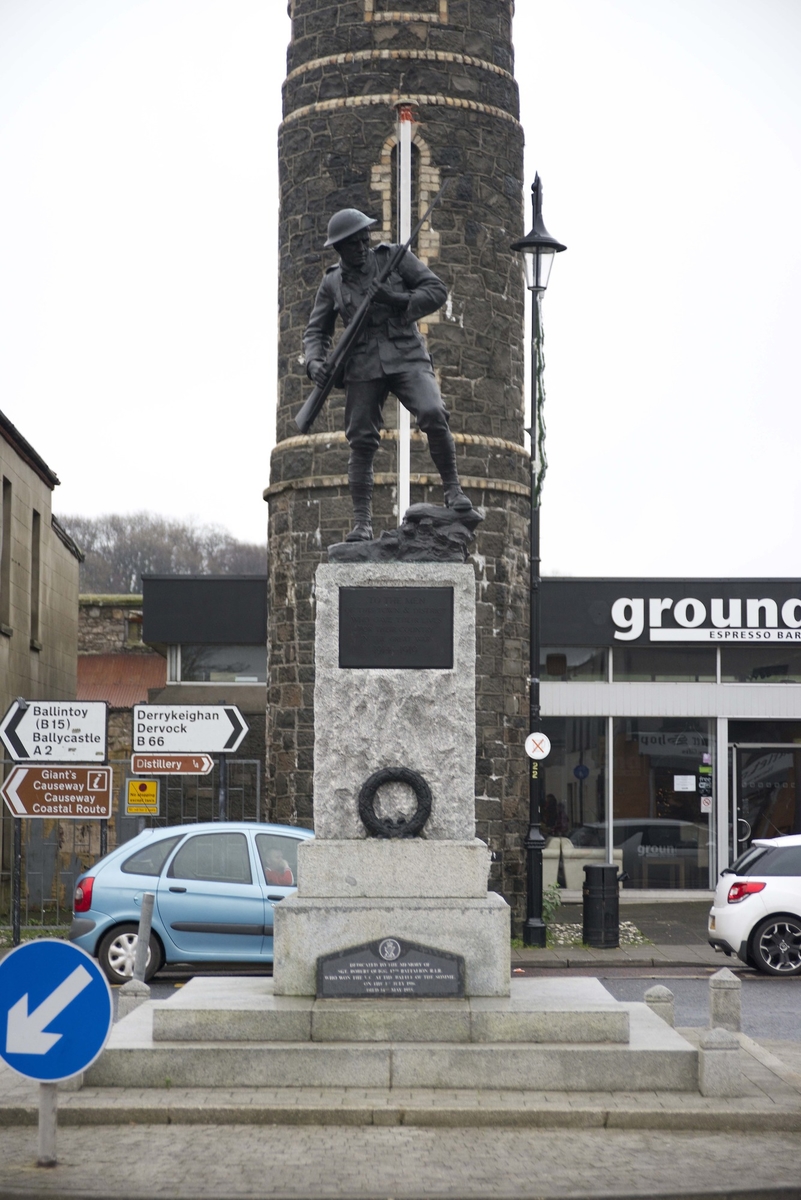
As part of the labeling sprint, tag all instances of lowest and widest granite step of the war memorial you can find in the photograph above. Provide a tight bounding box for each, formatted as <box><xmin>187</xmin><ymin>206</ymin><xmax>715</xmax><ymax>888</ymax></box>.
<box><xmin>85</xmin><ymin>1004</ymin><xmax>698</xmax><ymax>1092</ymax></box>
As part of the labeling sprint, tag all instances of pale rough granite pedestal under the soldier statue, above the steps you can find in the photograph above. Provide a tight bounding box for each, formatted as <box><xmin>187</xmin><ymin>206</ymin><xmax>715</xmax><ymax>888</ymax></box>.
<box><xmin>273</xmin><ymin>562</ymin><xmax>511</xmax><ymax>1002</ymax></box>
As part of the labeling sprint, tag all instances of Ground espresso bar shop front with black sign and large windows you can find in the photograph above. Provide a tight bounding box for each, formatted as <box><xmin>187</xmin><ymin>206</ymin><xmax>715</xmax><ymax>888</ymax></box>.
<box><xmin>540</xmin><ymin>578</ymin><xmax>801</xmax><ymax>893</ymax></box>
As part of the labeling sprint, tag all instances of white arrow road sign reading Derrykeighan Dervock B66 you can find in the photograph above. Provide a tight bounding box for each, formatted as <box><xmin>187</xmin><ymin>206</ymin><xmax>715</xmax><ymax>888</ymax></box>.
<box><xmin>133</xmin><ymin>704</ymin><xmax>248</xmax><ymax>754</ymax></box>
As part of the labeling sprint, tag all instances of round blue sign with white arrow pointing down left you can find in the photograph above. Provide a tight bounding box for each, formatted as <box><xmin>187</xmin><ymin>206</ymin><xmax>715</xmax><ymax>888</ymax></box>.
<box><xmin>0</xmin><ymin>938</ymin><xmax>114</xmax><ymax>1084</ymax></box>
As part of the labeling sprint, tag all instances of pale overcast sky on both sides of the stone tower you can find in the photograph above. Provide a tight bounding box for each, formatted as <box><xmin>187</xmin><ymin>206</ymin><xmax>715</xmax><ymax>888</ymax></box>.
<box><xmin>0</xmin><ymin>0</ymin><xmax>801</xmax><ymax>576</ymax></box>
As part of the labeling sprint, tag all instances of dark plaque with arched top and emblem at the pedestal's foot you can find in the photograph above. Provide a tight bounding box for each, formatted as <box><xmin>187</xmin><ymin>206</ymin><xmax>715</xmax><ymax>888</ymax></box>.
<box><xmin>317</xmin><ymin>937</ymin><xmax>464</xmax><ymax>1000</ymax></box>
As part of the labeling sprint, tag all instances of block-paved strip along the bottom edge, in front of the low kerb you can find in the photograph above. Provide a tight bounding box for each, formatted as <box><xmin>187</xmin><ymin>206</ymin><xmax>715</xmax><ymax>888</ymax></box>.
<box><xmin>0</xmin><ymin>1126</ymin><xmax>801</xmax><ymax>1200</ymax></box>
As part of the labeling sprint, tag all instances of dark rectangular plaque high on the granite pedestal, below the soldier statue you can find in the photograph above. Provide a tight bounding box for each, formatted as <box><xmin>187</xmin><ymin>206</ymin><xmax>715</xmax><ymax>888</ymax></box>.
<box><xmin>339</xmin><ymin>588</ymin><xmax>453</xmax><ymax>671</ymax></box>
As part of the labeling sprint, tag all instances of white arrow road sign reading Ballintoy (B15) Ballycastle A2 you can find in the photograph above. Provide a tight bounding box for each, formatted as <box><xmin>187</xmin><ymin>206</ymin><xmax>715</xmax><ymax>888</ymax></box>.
<box><xmin>0</xmin><ymin>700</ymin><xmax>108</xmax><ymax>762</ymax></box>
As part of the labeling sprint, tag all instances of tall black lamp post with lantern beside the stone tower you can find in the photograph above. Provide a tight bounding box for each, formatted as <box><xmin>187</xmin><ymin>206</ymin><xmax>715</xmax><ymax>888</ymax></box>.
<box><xmin>511</xmin><ymin>175</ymin><xmax>567</xmax><ymax>946</ymax></box>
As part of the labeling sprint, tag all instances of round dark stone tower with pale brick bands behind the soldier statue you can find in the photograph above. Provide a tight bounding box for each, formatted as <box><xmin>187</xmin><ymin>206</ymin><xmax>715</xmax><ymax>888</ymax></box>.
<box><xmin>264</xmin><ymin>0</ymin><xmax>529</xmax><ymax>920</ymax></box>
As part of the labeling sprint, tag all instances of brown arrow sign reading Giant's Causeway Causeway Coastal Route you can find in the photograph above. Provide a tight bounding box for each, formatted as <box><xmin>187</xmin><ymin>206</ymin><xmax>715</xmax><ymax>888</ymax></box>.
<box><xmin>0</xmin><ymin>763</ymin><xmax>112</xmax><ymax>821</ymax></box>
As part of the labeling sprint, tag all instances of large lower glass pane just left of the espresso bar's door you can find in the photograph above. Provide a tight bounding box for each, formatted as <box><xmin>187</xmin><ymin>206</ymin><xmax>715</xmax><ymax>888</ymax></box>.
<box><xmin>613</xmin><ymin>718</ymin><xmax>713</xmax><ymax>889</ymax></box>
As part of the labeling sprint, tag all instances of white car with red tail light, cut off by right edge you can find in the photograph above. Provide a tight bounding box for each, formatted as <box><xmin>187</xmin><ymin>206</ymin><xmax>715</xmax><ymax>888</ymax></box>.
<box><xmin>707</xmin><ymin>834</ymin><xmax>801</xmax><ymax>976</ymax></box>
